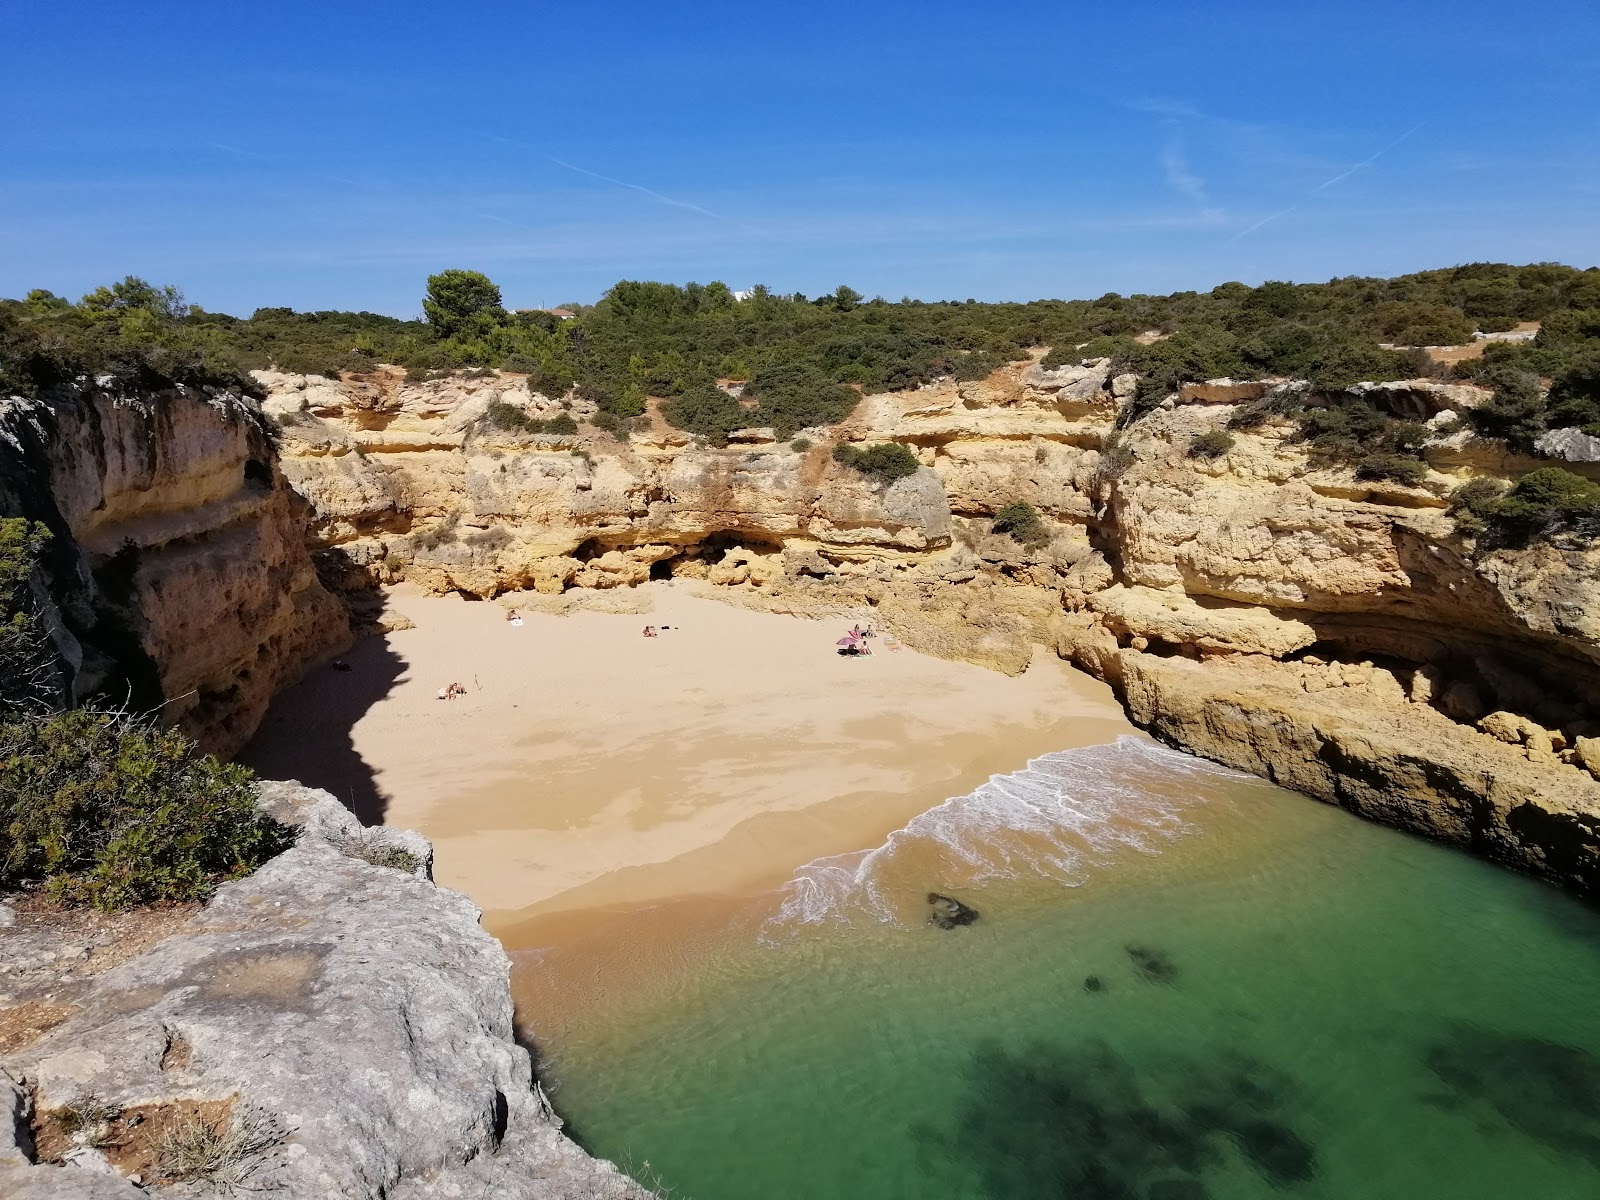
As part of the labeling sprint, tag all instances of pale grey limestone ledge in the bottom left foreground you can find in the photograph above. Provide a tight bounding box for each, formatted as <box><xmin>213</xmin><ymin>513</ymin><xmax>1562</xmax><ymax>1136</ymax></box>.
<box><xmin>0</xmin><ymin>784</ymin><xmax>648</xmax><ymax>1200</ymax></box>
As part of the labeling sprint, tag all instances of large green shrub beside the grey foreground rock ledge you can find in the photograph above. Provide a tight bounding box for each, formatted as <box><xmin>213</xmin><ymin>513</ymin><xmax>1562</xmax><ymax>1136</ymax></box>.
<box><xmin>0</xmin><ymin>709</ymin><xmax>291</xmax><ymax>909</ymax></box>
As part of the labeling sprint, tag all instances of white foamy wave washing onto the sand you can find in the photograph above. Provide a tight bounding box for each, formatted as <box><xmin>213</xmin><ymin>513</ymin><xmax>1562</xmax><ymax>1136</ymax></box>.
<box><xmin>768</xmin><ymin>736</ymin><xmax>1248</xmax><ymax>934</ymax></box>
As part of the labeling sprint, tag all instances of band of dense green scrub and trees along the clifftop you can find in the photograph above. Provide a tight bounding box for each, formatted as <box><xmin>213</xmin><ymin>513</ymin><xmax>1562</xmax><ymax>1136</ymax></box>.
<box><xmin>0</xmin><ymin>262</ymin><xmax>1600</xmax><ymax>458</ymax></box>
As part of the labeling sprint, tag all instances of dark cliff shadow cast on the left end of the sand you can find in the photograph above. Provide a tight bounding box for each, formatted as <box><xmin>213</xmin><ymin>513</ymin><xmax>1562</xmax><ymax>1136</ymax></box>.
<box><xmin>238</xmin><ymin>637</ymin><xmax>408</xmax><ymax>826</ymax></box>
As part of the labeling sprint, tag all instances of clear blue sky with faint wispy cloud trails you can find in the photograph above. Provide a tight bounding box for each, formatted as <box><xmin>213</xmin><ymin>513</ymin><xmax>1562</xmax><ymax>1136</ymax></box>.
<box><xmin>0</xmin><ymin>0</ymin><xmax>1600</xmax><ymax>315</ymax></box>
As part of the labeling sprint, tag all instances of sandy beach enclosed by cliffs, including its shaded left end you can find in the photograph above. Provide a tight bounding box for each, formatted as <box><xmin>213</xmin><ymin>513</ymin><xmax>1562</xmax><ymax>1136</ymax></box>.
<box><xmin>243</xmin><ymin>582</ymin><xmax>1131</xmax><ymax>944</ymax></box>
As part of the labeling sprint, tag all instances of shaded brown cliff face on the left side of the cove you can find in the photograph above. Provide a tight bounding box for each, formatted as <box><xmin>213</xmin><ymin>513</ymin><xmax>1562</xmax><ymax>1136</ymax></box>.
<box><xmin>0</xmin><ymin>384</ymin><xmax>349</xmax><ymax>754</ymax></box>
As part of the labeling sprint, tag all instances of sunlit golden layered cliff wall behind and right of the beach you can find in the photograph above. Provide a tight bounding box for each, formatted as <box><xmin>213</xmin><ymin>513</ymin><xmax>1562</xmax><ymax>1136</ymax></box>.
<box><xmin>261</xmin><ymin>362</ymin><xmax>1600</xmax><ymax>890</ymax></box>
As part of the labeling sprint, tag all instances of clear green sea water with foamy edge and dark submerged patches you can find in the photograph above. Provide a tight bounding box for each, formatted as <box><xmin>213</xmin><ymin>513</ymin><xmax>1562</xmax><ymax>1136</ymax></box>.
<box><xmin>531</xmin><ymin>738</ymin><xmax>1600</xmax><ymax>1200</ymax></box>
